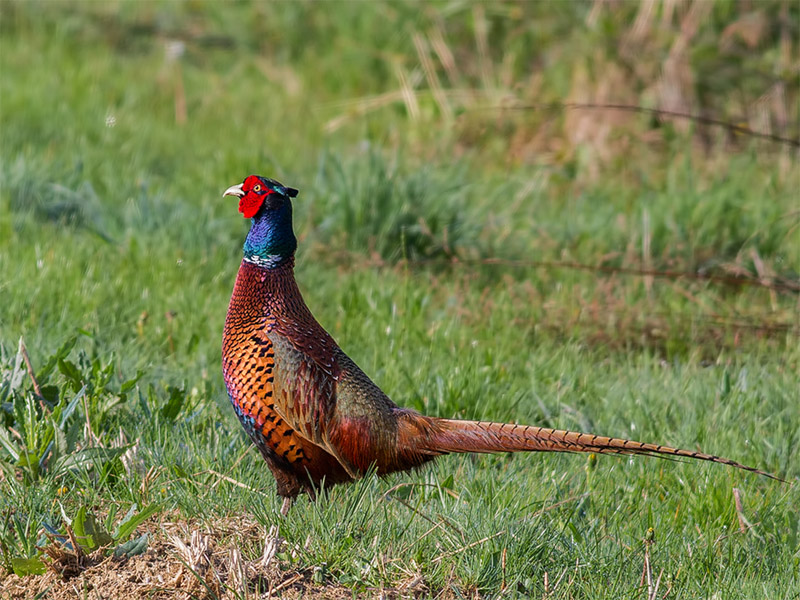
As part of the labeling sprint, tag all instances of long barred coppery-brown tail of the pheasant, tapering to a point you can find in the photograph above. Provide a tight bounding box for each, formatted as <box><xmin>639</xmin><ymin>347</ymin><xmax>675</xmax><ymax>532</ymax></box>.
<box><xmin>420</xmin><ymin>419</ymin><xmax>783</xmax><ymax>481</ymax></box>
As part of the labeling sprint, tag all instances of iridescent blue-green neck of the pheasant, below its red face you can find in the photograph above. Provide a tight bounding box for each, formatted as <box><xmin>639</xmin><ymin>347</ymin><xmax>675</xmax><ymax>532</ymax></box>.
<box><xmin>244</xmin><ymin>201</ymin><xmax>297</xmax><ymax>269</ymax></box>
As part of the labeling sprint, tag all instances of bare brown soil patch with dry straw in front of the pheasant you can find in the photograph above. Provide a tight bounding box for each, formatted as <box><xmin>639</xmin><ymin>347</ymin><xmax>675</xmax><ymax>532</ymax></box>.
<box><xmin>0</xmin><ymin>522</ymin><xmax>425</xmax><ymax>600</ymax></box>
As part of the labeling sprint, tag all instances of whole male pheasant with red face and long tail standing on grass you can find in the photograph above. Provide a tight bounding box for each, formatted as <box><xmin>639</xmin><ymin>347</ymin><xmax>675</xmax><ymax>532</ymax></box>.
<box><xmin>222</xmin><ymin>175</ymin><xmax>775</xmax><ymax>514</ymax></box>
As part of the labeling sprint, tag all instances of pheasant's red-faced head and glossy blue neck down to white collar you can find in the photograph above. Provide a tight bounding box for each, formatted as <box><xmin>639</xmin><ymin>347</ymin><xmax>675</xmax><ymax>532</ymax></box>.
<box><xmin>223</xmin><ymin>175</ymin><xmax>297</xmax><ymax>269</ymax></box>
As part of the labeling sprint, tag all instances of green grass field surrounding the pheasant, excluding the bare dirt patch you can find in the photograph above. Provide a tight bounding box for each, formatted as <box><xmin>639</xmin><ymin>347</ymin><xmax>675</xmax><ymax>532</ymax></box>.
<box><xmin>0</xmin><ymin>2</ymin><xmax>800</xmax><ymax>599</ymax></box>
